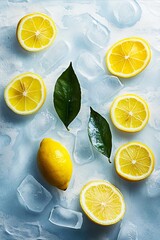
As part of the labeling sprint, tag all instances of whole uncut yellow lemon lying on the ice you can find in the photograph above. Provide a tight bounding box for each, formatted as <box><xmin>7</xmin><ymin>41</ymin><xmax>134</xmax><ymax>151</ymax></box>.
<box><xmin>37</xmin><ymin>138</ymin><xmax>73</xmax><ymax>190</ymax></box>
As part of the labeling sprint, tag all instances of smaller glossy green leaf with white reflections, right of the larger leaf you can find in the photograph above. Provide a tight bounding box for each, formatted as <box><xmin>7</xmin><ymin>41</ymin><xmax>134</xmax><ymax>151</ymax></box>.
<box><xmin>88</xmin><ymin>108</ymin><xmax>112</xmax><ymax>162</ymax></box>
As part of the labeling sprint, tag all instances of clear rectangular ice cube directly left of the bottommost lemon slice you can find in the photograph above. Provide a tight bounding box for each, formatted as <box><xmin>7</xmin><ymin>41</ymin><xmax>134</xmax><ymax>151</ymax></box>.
<box><xmin>49</xmin><ymin>206</ymin><xmax>83</xmax><ymax>229</ymax></box>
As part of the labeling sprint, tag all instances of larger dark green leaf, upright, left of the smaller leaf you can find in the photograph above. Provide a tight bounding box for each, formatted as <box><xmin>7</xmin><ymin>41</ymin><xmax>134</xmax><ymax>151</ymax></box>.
<box><xmin>54</xmin><ymin>63</ymin><xmax>81</xmax><ymax>129</ymax></box>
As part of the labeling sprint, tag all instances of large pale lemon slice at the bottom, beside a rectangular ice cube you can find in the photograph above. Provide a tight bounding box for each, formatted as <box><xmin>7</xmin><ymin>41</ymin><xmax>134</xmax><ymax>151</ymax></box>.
<box><xmin>80</xmin><ymin>180</ymin><xmax>125</xmax><ymax>225</ymax></box>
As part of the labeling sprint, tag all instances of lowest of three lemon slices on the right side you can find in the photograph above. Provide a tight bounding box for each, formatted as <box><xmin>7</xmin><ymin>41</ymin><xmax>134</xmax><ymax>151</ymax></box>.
<box><xmin>115</xmin><ymin>142</ymin><xmax>155</xmax><ymax>181</ymax></box>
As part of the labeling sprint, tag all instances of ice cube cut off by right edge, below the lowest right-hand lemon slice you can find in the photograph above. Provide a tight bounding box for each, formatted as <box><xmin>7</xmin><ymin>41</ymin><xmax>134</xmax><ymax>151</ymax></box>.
<box><xmin>146</xmin><ymin>169</ymin><xmax>160</xmax><ymax>198</ymax></box>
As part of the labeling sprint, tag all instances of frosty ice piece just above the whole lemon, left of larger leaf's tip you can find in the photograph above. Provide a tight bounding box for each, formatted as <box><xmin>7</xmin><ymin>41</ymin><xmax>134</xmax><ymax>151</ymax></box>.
<box><xmin>27</xmin><ymin>110</ymin><xmax>57</xmax><ymax>139</ymax></box>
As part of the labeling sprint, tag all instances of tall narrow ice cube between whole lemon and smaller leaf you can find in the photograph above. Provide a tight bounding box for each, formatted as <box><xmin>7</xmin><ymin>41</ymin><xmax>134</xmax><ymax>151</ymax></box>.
<box><xmin>74</xmin><ymin>129</ymin><xmax>94</xmax><ymax>164</ymax></box>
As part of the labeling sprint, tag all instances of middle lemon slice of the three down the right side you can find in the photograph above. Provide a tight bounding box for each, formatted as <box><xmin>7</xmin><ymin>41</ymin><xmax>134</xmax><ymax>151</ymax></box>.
<box><xmin>110</xmin><ymin>94</ymin><xmax>150</xmax><ymax>132</ymax></box>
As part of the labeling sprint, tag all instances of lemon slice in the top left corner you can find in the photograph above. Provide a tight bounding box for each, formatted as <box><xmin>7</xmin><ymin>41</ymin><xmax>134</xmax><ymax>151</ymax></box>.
<box><xmin>17</xmin><ymin>13</ymin><xmax>57</xmax><ymax>52</ymax></box>
